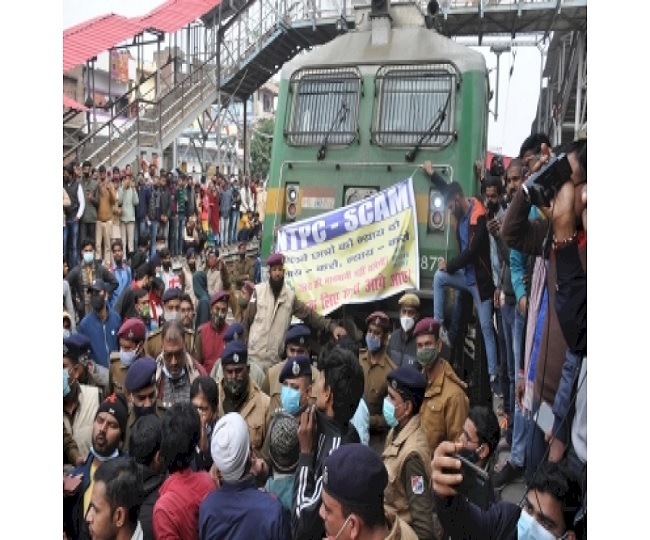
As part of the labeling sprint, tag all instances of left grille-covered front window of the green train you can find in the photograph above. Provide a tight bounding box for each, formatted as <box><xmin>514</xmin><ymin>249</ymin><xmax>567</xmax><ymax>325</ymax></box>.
<box><xmin>285</xmin><ymin>68</ymin><xmax>361</xmax><ymax>146</ymax></box>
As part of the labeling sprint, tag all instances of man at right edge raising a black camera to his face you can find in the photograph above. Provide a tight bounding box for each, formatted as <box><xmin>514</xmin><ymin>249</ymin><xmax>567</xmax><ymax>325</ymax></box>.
<box><xmin>501</xmin><ymin>140</ymin><xmax>587</xmax><ymax>486</ymax></box>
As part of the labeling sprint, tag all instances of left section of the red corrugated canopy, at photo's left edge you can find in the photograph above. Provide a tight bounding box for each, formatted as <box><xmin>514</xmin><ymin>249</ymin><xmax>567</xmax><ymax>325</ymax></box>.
<box><xmin>63</xmin><ymin>13</ymin><xmax>145</xmax><ymax>73</ymax></box>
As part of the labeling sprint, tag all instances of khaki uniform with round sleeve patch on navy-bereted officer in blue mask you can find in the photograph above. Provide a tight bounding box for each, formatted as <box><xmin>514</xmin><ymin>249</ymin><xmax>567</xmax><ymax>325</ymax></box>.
<box><xmin>381</xmin><ymin>414</ymin><xmax>434</xmax><ymax>540</ymax></box>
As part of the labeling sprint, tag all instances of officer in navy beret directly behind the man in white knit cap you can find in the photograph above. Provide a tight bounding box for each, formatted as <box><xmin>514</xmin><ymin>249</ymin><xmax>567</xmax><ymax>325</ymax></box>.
<box><xmin>219</xmin><ymin>341</ymin><xmax>270</xmax><ymax>452</ymax></box>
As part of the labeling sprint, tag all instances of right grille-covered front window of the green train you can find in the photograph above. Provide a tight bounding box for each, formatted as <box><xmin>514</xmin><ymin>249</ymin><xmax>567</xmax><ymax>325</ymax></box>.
<box><xmin>371</xmin><ymin>64</ymin><xmax>456</xmax><ymax>148</ymax></box>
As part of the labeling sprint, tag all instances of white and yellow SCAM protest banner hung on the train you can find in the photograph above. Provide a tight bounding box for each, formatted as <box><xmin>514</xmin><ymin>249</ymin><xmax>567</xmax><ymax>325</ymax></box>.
<box><xmin>276</xmin><ymin>178</ymin><xmax>420</xmax><ymax>315</ymax></box>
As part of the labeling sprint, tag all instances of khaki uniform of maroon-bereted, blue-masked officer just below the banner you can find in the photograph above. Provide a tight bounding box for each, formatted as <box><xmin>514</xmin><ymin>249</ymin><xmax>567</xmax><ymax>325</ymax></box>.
<box><xmin>359</xmin><ymin>349</ymin><xmax>395</xmax><ymax>453</ymax></box>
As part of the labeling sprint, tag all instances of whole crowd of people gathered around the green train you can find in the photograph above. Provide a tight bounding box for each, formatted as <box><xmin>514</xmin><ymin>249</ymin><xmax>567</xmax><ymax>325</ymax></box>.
<box><xmin>63</xmin><ymin>134</ymin><xmax>586</xmax><ymax>540</ymax></box>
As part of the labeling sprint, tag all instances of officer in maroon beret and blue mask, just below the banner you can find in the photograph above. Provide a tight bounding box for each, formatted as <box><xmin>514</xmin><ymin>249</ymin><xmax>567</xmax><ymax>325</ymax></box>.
<box><xmin>359</xmin><ymin>311</ymin><xmax>395</xmax><ymax>454</ymax></box>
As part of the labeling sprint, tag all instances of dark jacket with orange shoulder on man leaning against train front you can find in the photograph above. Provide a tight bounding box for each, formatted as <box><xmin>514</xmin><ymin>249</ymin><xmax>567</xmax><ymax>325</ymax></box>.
<box><xmin>447</xmin><ymin>197</ymin><xmax>494</xmax><ymax>301</ymax></box>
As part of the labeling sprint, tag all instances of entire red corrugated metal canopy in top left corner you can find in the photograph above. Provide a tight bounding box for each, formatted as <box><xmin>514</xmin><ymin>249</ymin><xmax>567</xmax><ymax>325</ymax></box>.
<box><xmin>63</xmin><ymin>0</ymin><xmax>222</xmax><ymax>73</ymax></box>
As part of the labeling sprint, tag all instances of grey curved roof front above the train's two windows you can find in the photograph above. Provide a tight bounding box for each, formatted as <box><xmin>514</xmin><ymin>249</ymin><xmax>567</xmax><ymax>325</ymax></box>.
<box><xmin>281</xmin><ymin>27</ymin><xmax>486</xmax><ymax>79</ymax></box>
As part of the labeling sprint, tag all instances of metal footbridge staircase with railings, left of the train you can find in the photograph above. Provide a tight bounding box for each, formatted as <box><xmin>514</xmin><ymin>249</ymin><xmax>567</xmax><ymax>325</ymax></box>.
<box><xmin>64</xmin><ymin>0</ymin><xmax>354</xmax><ymax>168</ymax></box>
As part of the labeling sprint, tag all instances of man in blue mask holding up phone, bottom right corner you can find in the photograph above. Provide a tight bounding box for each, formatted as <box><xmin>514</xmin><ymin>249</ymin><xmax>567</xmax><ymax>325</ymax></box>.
<box><xmin>431</xmin><ymin>441</ymin><xmax>581</xmax><ymax>540</ymax></box>
